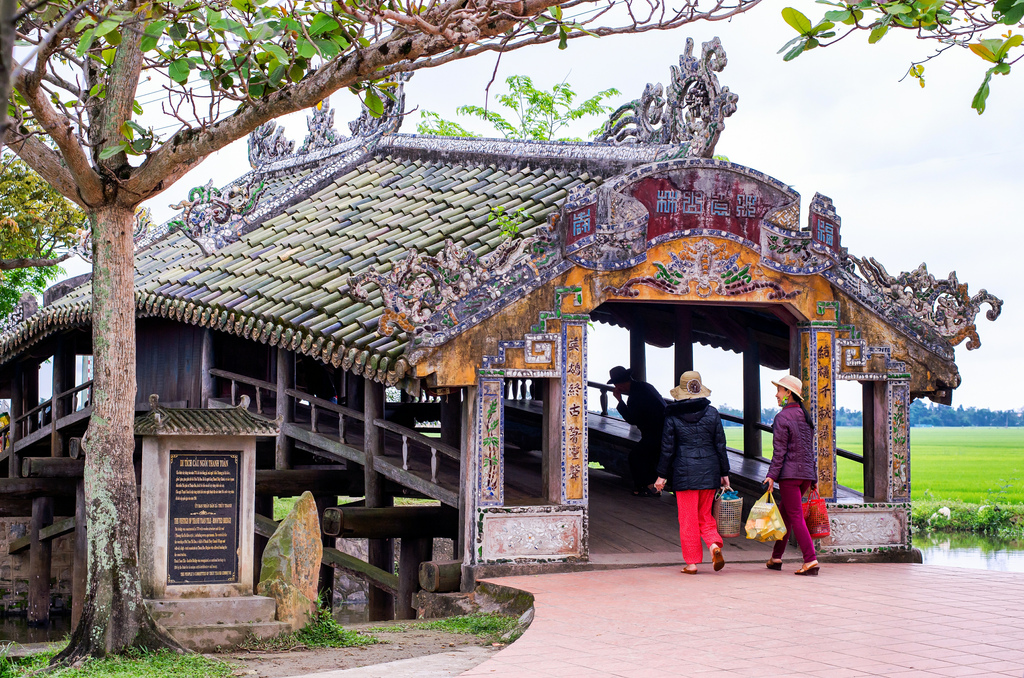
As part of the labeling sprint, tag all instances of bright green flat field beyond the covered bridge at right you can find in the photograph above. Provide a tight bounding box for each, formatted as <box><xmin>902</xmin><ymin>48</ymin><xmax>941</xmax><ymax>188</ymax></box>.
<box><xmin>725</xmin><ymin>426</ymin><xmax>1024</xmax><ymax>504</ymax></box>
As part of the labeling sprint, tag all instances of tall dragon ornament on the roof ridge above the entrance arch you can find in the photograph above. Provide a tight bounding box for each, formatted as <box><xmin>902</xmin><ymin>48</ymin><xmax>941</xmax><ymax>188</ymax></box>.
<box><xmin>596</xmin><ymin>38</ymin><xmax>739</xmax><ymax>158</ymax></box>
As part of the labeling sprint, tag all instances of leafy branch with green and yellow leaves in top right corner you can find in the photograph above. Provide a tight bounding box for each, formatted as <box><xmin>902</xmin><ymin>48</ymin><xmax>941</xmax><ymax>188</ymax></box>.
<box><xmin>779</xmin><ymin>0</ymin><xmax>1024</xmax><ymax>115</ymax></box>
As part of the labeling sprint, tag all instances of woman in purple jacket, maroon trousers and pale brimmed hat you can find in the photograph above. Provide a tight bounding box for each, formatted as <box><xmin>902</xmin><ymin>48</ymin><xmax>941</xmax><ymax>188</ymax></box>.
<box><xmin>765</xmin><ymin>375</ymin><xmax>818</xmax><ymax>577</ymax></box>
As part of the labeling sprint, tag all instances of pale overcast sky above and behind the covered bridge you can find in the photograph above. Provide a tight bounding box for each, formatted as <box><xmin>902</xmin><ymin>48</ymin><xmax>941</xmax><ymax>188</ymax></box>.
<box><xmin>58</xmin><ymin>2</ymin><xmax>1024</xmax><ymax>409</ymax></box>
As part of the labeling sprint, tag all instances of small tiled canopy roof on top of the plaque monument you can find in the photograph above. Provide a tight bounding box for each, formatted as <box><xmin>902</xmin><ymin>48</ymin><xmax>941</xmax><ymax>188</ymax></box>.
<box><xmin>135</xmin><ymin>393</ymin><xmax>280</xmax><ymax>435</ymax></box>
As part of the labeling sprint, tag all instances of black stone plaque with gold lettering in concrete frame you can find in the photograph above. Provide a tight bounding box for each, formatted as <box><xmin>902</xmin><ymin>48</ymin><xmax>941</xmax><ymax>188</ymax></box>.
<box><xmin>167</xmin><ymin>450</ymin><xmax>242</xmax><ymax>584</ymax></box>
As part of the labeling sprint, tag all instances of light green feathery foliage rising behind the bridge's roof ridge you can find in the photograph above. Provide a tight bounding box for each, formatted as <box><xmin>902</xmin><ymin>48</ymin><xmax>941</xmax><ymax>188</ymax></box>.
<box><xmin>417</xmin><ymin>75</ymin><xmax>620</xmax><ymax>141</ymax></box>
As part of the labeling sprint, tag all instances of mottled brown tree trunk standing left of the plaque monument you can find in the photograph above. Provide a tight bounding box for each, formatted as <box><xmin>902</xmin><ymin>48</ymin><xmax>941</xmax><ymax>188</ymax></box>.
<box><xmin>54</xmin><ymin>206</ymin><xmax>180</xmax><ymax>664</ymax></box>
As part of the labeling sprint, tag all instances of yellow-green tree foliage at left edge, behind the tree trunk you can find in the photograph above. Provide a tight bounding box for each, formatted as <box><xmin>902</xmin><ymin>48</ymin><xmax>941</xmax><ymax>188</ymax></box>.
<box><xmin>0</xmin><ymin>158</ymin><xmax>86</xmax><ymax>317</ymax></box>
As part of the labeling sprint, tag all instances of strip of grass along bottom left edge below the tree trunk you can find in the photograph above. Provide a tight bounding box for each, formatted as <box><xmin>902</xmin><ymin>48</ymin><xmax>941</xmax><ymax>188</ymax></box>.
<box><xmin>0</xmin><ymin>650</ymin><xmax>234</xmax><ymax>678</ymax></box>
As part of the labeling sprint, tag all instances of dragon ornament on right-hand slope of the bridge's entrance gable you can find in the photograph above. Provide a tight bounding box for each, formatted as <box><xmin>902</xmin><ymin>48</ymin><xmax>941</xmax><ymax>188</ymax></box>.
<box><xmin>850</xmin><ymin>256</ymin><xmax>1002</xmax><ymax>350</ymax></box>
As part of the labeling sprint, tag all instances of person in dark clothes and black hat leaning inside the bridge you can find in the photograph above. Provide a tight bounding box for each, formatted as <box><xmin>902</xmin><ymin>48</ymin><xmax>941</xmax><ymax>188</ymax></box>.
<box><xmin>608</xmin><ymin>367</ymin><xmax>665</xmax><ymax>497</ymax></box>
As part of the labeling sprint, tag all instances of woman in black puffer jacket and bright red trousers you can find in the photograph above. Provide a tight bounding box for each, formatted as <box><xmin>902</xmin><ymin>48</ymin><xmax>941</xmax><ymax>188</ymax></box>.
<box><xmin>654</xmin><ymin>372</ymin><xmax>729</xmax><ymax>575</ymax></box>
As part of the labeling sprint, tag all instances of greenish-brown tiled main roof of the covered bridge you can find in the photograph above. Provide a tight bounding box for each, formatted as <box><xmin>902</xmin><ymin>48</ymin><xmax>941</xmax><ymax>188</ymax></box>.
<box><xmin>0</xmin><ymin>135</ymin><xmax>665</xmax><ymax>386</ymax></box>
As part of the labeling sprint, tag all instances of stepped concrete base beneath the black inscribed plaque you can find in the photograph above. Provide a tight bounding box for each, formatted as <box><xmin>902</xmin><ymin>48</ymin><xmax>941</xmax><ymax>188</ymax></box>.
<box><xmin>145</xmin><ymin>596</ymin><xmax>292</xmax><ymax>652</ymax></box>
